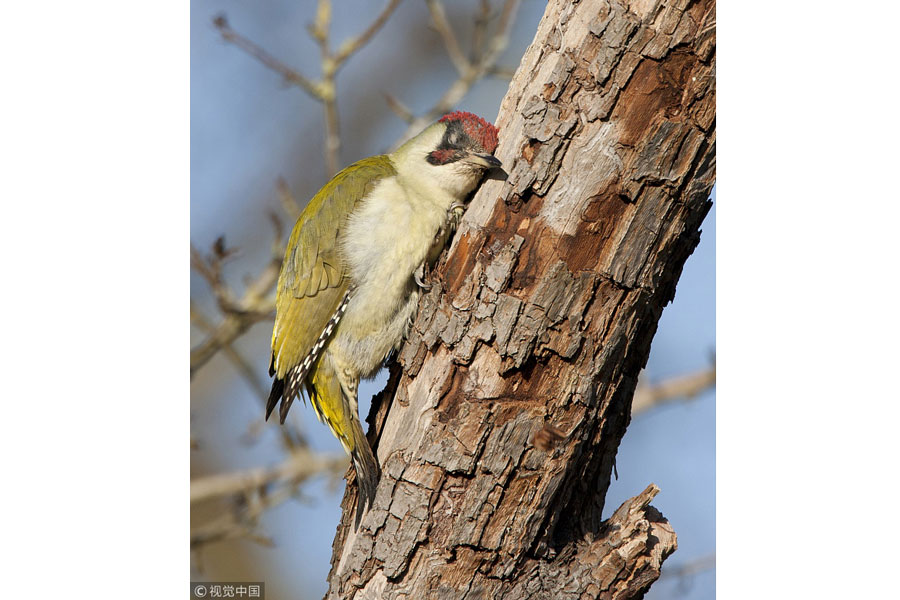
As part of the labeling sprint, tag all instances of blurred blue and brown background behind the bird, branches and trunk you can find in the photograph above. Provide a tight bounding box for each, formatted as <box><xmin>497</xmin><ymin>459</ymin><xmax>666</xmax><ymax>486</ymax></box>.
<box><xmin>190</xmin><ymin>0</ymin><xmax>716</xmax><ymax>600</ymax></box>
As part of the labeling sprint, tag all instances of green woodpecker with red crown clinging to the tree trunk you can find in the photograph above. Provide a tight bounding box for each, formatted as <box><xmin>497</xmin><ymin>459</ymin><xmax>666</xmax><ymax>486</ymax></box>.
<box><xmin>266</xmin><ymin>112</ymin><xmax>500</xmax><ymax>528</ymax></box>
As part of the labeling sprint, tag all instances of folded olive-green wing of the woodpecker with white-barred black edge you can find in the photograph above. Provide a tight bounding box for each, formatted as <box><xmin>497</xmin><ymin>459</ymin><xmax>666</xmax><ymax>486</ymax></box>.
<box><xmin>269</xmin><ymin>156</ymin><xmax>396</xmax><ymax>400</ymax></box>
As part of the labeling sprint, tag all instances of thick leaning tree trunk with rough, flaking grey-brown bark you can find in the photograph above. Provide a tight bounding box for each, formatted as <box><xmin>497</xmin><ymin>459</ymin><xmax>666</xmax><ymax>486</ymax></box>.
<box><xmin>326</xmin><ymin>0</ymin><xmax>716</xmax><ymax>600</ymax></box>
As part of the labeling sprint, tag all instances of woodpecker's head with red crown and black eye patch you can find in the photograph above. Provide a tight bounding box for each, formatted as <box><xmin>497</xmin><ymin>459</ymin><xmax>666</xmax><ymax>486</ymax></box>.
<box><xmin>397</xmin><ymin>111</ymin><xmax>502</xmax><ymax>199</ymax></box>
